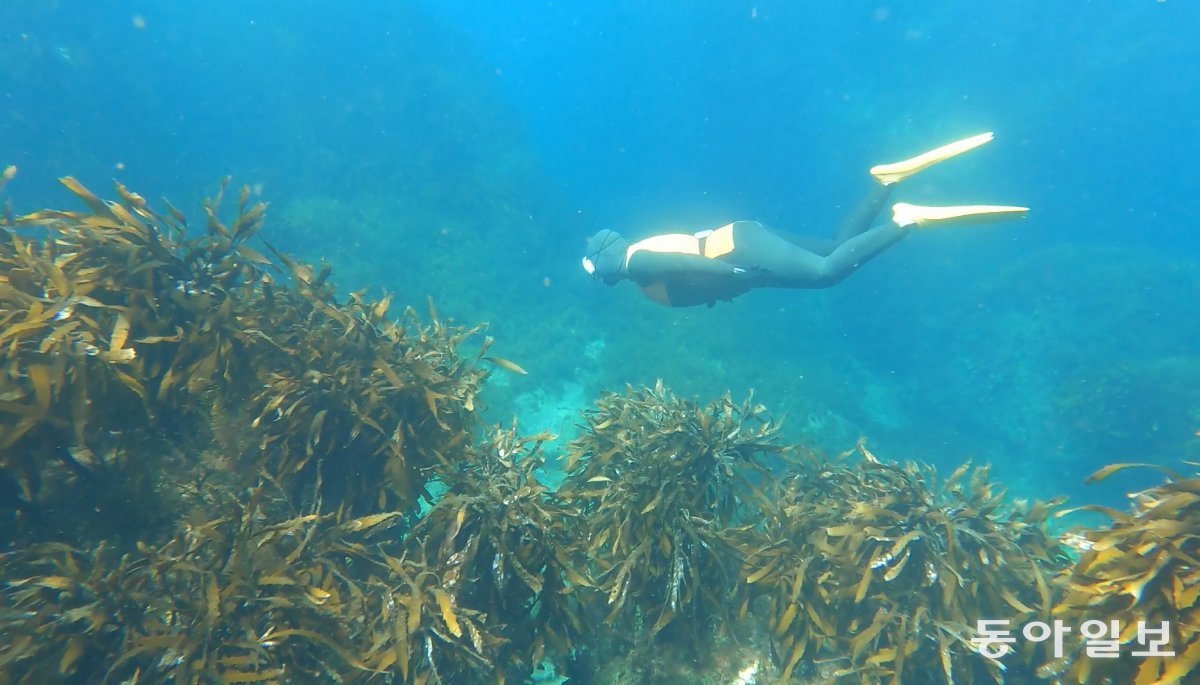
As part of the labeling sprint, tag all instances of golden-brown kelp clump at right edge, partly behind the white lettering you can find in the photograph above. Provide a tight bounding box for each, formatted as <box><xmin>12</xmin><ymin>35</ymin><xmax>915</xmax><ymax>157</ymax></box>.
<box><xmin>1039</xmin><ymin>464</ymin><xmax>1200</xmax><ymax>685</ymax></box>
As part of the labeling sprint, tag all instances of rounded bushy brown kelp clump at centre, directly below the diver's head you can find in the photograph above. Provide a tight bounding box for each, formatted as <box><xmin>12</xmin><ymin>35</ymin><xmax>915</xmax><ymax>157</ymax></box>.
<box><xmin>560</xmin><ymin>383</ymin><xmax>784</xmax><ymax>648</ymax></box>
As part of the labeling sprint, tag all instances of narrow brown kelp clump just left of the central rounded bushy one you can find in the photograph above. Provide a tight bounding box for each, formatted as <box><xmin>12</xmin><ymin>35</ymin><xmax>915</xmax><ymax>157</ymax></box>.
<box><xmin>407</xmin><ymin>428</ymin><xmax>592</xmax><ymax>679</ymax></box>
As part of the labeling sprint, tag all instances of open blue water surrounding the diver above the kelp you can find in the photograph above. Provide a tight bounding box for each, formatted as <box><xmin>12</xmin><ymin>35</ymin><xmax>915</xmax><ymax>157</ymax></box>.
<box><xmin>0</xmin><ymin>0</ymin><xmax>1200</xmax><ymax>508</ymax></box>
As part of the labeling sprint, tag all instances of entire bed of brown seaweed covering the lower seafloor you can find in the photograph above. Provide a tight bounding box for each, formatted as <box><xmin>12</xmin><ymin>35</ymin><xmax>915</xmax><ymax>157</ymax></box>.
<box><xmin>0</xmin><ymin>170</ymin><xmax>1200</xmax><ymax>685</ymax></box>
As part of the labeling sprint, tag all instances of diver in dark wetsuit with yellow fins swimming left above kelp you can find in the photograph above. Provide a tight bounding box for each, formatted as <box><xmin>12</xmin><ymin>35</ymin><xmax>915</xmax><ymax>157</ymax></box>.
<box><xmin>583</xmin><ymin>133</ymin><xmax>1030</xmax><ymax>307</ymax></box>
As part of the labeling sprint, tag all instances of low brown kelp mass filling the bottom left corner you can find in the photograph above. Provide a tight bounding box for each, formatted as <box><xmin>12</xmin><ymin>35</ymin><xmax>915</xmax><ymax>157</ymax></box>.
<box><xmin>0</xmin><ymin>485</ymin><xmax>503</xmax><ymax>683</ymax></box>
